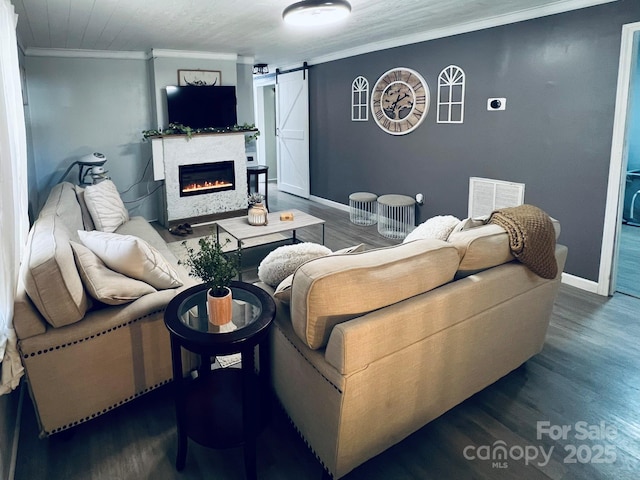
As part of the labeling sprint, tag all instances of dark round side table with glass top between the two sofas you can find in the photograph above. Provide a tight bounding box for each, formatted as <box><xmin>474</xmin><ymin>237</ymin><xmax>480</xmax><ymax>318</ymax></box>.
<box><xmin>164</xmin><ymin>282</ymin><xmax>275</xmax><ymax>479</ymax></box>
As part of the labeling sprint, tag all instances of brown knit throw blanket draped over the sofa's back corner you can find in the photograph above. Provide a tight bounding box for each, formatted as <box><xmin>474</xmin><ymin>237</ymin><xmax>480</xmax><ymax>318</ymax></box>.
<box><xmin>489</xmin><ymin>205</ymin><xmax>558</xmax><ymax>279</ymax></box>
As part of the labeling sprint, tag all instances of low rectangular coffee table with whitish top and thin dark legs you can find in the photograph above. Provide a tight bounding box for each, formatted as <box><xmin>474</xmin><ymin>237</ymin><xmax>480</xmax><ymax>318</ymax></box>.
<box><xmin>216</xmin><ymin>210</ymin><xmax>324</xmax><ymax>280</ymax></box>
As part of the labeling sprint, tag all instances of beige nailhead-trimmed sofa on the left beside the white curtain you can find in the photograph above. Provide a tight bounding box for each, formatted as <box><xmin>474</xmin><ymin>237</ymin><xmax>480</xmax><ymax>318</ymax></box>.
<box><xmin>14</xmin><ymin>183</ymin><xmax>194</xmax><ymax>436</ymax></box>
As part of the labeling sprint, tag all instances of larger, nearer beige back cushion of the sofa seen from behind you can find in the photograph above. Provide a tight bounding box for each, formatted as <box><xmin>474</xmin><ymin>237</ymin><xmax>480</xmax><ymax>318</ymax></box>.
<box><xmin>291</xmin><ymin>239</ymin><xmax>460</xmax><ymax>349</ymax></box>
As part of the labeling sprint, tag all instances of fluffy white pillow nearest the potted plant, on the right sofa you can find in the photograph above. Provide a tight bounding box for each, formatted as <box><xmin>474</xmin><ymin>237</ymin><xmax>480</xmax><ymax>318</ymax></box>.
<box><xmin>258</xmin><ymin>242</ymin><xmax>331</xmax><ymax>288</ymax></box>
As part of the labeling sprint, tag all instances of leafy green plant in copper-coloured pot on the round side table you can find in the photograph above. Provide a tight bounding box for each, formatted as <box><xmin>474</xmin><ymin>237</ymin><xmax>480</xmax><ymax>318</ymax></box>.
<box><xmin>180</xmin><ymin>235</ymin><xmax>241</xmax><ymax>326</ymax></box>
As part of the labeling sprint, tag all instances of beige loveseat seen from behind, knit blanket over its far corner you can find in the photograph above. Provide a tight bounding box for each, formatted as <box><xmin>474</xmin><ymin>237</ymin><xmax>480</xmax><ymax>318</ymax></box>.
<box><xmin>261</xmin><ymin>216</ymin><xmax>567</xmax><ymax>478</ymax></box>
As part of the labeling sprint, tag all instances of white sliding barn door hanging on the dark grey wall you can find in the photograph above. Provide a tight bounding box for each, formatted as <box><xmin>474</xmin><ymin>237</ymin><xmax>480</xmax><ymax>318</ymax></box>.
<box><xmin>276</xmin><ymin>70</ymin><xmax>309</xmax><ymax>198</ymax></box>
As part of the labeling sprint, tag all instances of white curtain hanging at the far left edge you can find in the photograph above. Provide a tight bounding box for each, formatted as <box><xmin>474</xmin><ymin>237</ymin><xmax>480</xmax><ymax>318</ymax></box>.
<box><xmin>0</xmin><ymin>0</ymin><xmax>29</xmax><ymax>395</ymax></box>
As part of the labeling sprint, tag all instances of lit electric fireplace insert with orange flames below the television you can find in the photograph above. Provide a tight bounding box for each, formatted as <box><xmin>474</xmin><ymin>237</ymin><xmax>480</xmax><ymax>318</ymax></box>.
<box><xmin>178</xmin><ymin>160</ymin><xmax>236</xmax><ymax>197</ymax></box>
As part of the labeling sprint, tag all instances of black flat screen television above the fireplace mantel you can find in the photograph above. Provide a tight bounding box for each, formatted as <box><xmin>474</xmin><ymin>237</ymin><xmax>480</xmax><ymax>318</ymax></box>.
<box><xmin>167</xmin><ymin>85</ymin><xmax>238</xmax><ymax>128</ymax></box>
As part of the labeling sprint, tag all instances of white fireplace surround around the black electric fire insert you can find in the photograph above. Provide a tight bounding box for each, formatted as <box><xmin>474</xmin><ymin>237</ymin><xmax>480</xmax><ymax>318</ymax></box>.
<box><xmin>150</xmin><ymin>132</ymin><xmax>247</xmax><ymax>226</ymax></box>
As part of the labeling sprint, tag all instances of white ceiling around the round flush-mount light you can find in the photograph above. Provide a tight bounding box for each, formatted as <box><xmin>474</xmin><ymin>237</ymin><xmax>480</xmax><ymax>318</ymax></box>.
<box><xmin>11</xmin><ymin>0</ymin><xmax>612</xmax><ymax>66</ymax></box>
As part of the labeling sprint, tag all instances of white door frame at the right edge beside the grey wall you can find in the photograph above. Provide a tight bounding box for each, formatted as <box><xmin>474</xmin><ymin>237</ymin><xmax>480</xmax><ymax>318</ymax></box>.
<box><xmin>596</xmin><ymin>22</ymin><xmax>640</xmax><ymax>295</ymax></box>
